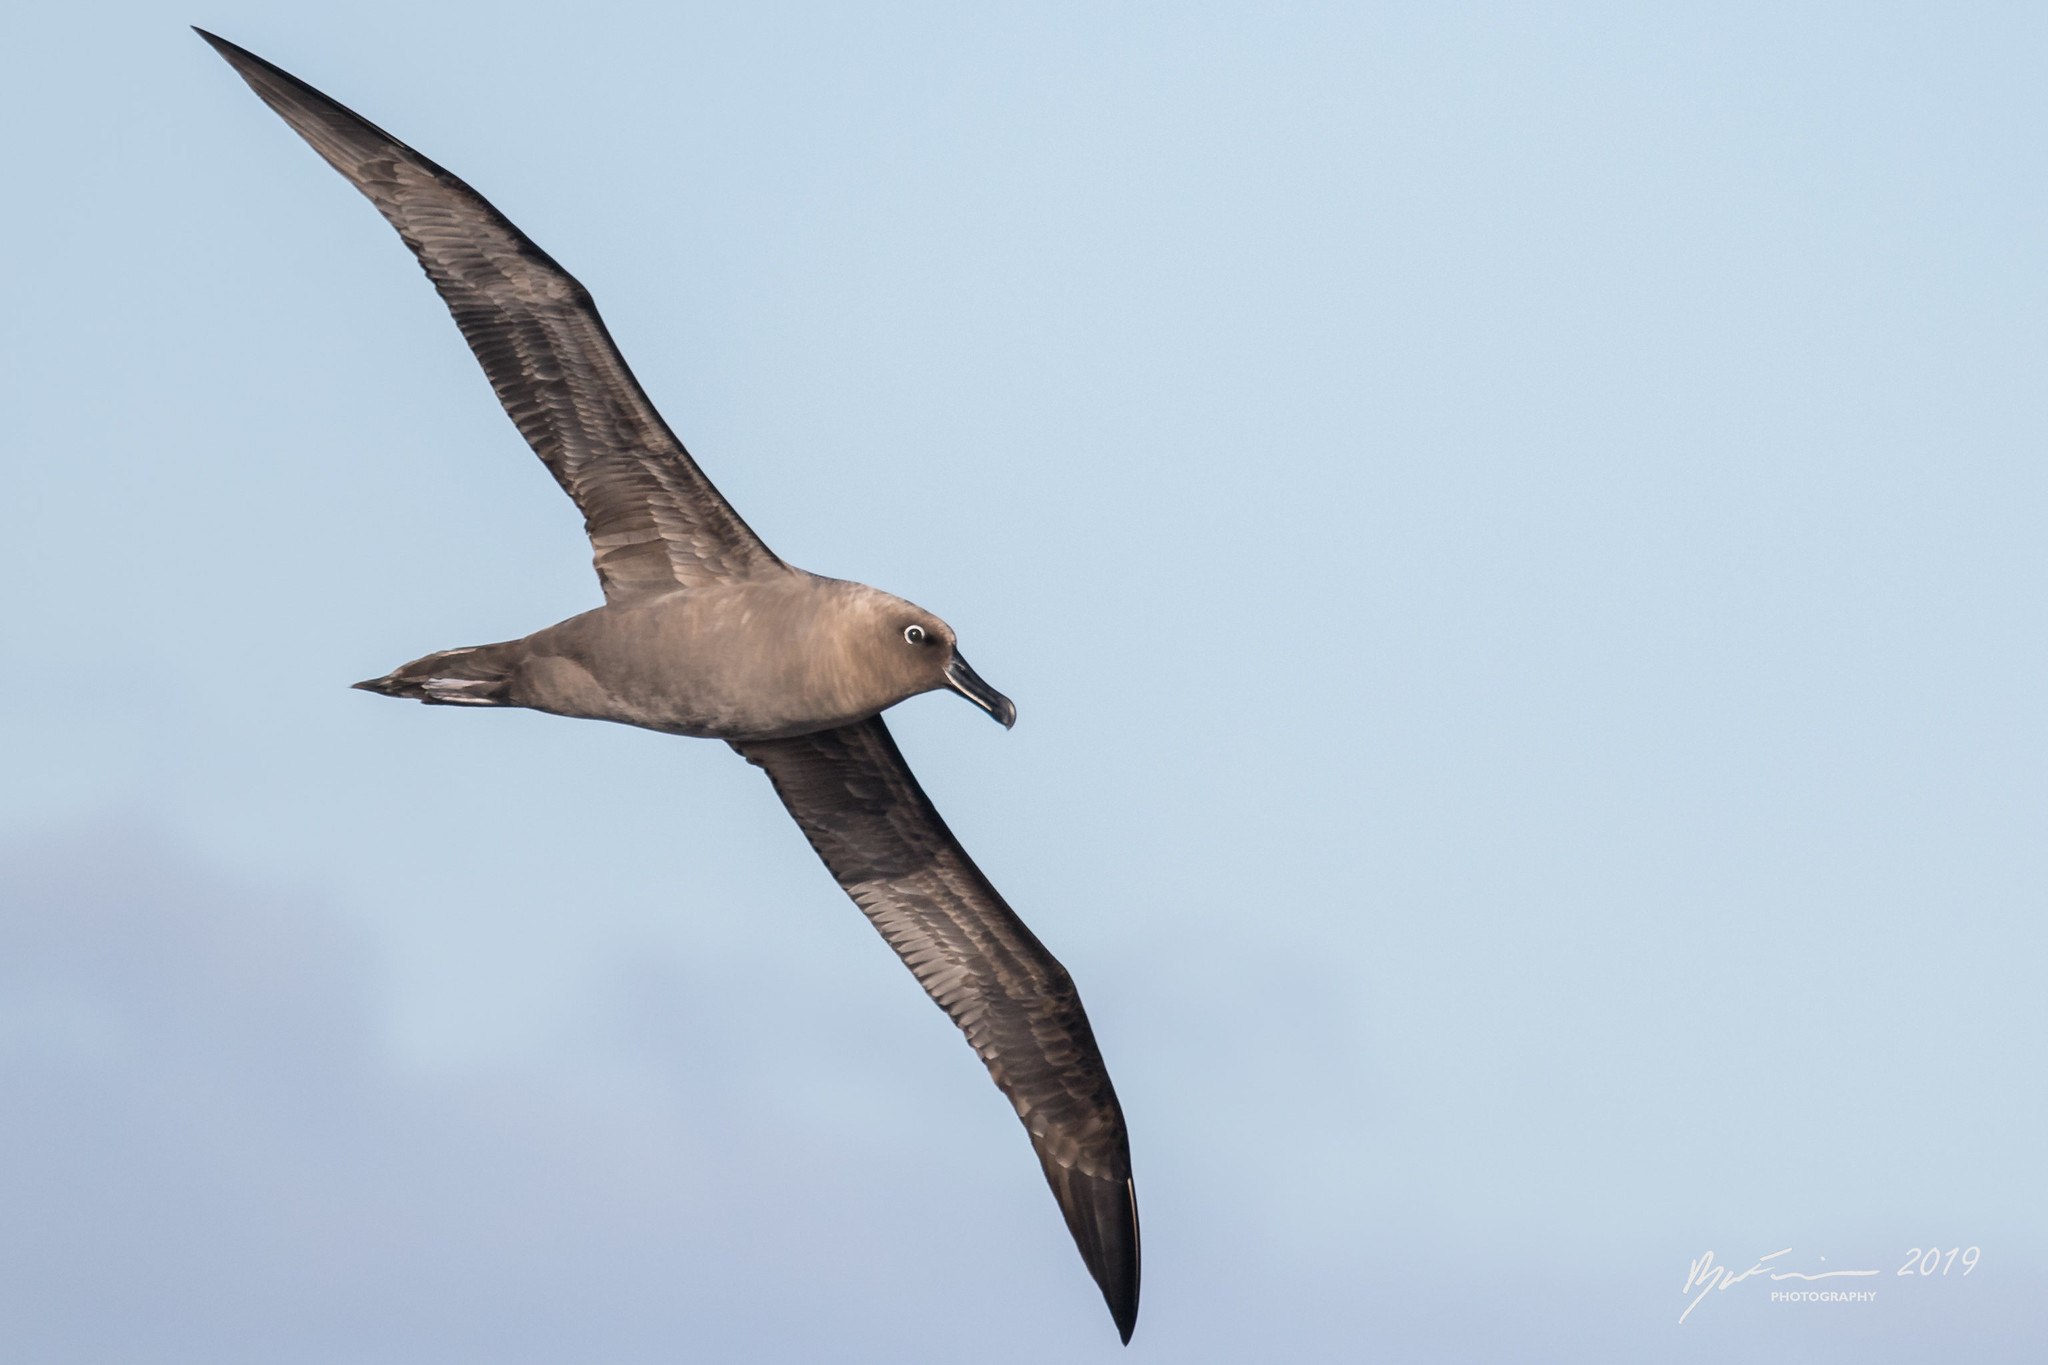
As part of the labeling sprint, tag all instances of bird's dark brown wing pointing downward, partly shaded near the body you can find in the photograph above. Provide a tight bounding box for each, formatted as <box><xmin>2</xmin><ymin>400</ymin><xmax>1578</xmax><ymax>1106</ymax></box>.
<box><xmin>733</xmin><ymin>716</ymin><xmax>1139</xmax><ymax>1340</ymax></box>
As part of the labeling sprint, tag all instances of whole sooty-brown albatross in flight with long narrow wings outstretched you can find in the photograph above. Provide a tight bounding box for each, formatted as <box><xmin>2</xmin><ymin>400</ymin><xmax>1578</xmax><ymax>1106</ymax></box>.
<box><xmin>197</xmin><ymin>29</ymin><xmax>1139</xmax><ymax>1342</ymax></box>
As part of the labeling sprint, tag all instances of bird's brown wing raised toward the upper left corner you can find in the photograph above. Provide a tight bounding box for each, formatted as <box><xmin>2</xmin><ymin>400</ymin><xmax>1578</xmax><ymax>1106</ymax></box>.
<box><xmin>197</xmin><ymin>29</ymin><xmax>782</xmax><ymax>600</ymax></box>
